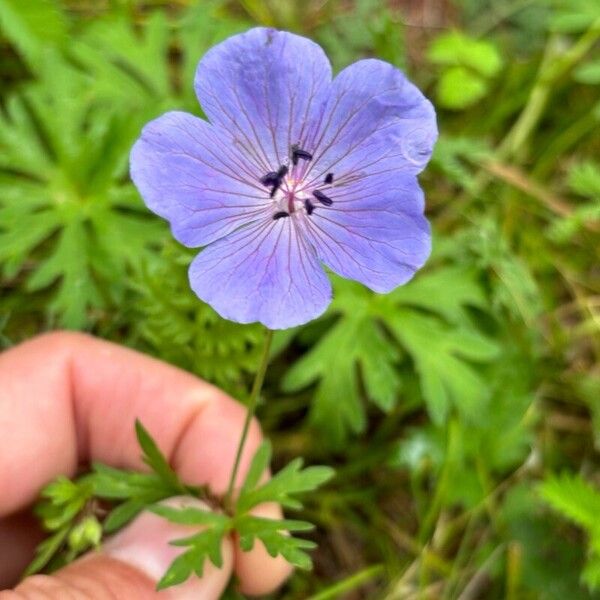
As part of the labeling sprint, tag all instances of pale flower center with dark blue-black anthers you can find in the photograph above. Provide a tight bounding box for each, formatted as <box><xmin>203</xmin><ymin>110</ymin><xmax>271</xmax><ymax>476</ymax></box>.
<box><xmin>259</xmin><ymin>144</ymin><xmax>333</xmax><ymax>220</ymax></box>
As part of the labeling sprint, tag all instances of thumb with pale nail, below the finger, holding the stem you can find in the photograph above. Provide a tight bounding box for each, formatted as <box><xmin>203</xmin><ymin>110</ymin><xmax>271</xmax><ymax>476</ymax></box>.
<box><xmin>0</xmin><ymin>499</ymin><xmax>233</xmax><ymax>600</ymax></box>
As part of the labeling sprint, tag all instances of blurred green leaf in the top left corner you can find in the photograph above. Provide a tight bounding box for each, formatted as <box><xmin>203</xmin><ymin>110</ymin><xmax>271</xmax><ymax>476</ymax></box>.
<box><xmin>0</xmin><ymin>0</ymin><xmax>67</xmax><ymax>71</ymax></box>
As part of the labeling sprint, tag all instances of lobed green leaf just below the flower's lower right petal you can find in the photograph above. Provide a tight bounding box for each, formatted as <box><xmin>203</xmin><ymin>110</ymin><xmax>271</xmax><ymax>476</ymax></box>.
<box><xmin>283</xmin><ymin>267</ymin><xmax>498</xmax><ymax>446</ymax></box>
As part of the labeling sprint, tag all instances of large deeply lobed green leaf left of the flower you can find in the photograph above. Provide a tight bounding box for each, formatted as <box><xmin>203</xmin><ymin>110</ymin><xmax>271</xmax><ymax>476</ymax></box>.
<box><xmin>0</xmin><ymin>54</ymin><xmax>164</xmax><ymax>328</ymax></box>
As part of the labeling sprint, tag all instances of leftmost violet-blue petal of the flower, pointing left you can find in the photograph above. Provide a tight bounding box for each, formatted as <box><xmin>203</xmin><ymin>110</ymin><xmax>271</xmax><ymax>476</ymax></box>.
<box><xmin>131</xmin><ymin>112</ymin><xmax>270</xmax><ymax>247</ymax></box>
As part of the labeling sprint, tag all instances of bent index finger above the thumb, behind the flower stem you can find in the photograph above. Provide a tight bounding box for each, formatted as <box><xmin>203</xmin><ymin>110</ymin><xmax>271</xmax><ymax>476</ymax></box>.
<box><xmin>0</xmin><ymin>333</ymin><xmax>286</xmax><ymax>593</ymax></box>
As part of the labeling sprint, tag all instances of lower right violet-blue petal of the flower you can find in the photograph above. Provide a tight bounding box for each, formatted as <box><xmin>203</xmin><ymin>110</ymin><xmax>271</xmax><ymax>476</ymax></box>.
<box><xmin>305</xmin><ymin>172</ymin><xmax>431</xmax><ymax>293</ymax></box>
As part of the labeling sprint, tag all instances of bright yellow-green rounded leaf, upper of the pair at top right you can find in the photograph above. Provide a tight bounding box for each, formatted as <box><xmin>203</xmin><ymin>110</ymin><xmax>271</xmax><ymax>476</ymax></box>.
<box><xmin>427</xmin><ymin>31</ymin><xmax>503</xmax><ymax>78</ymax></box>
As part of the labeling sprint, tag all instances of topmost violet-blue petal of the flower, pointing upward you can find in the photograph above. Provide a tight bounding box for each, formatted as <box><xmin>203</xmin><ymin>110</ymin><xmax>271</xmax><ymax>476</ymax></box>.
<box><xmin>195</xmin><ymin>27</ymin><xmax>331</xmax><ymax>177</ymax></box>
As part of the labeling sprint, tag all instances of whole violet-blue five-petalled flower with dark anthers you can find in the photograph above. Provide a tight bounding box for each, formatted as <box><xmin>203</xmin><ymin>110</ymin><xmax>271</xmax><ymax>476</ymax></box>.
<box><xmin>131</xmin><ymin>28</ymin><xmax>437</xmax><ymax>329</ymax></box>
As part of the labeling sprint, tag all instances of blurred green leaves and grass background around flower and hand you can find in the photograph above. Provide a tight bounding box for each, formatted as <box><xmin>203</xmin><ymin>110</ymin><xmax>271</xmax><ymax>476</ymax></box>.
<box><xmin>0</xmin><ymin>0</ymin><xmax>600</xmax><ymax>600</ymax></box>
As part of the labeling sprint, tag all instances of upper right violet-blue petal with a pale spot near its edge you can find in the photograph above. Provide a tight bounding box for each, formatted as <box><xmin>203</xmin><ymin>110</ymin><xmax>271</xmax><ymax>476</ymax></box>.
<box><xmin>305</xmin><ymin>59</ymin><xmax>437</xmax><ymax>188</ymax></box>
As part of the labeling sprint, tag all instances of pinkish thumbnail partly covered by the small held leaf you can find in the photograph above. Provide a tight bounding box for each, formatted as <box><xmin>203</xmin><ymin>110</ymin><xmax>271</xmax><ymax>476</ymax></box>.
<box><xmin>102</xmin><ymin>498</ymin><xmax>233</xmax><ymax>600</ymax></box>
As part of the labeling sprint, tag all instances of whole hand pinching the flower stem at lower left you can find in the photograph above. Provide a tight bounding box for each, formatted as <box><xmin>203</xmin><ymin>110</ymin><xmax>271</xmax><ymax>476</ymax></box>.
<box><xmin>0</xmin><ymin>333</ymin><xmax>290</xmax><ymax>600</ymax></box>
